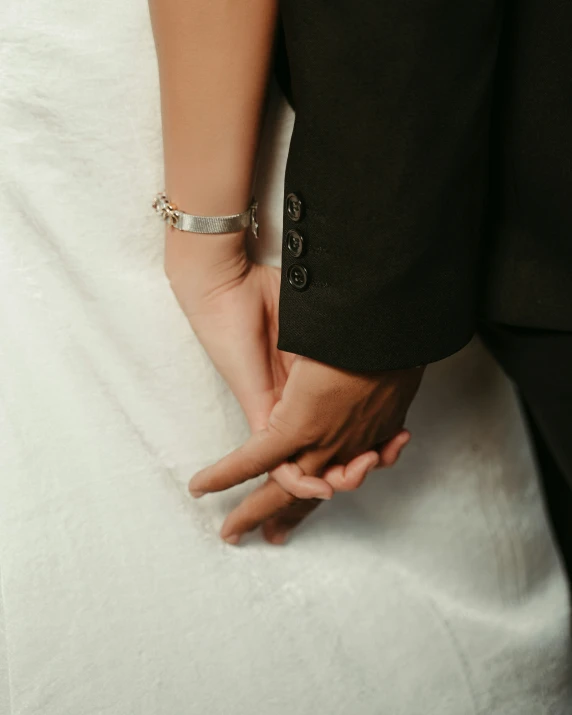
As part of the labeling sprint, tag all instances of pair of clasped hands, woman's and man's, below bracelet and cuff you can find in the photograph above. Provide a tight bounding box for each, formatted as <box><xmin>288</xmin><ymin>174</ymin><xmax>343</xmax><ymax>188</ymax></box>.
<box><xmin>165</xmin><ymin>232</ymin><xmax>423</xmax><ymax>543</ymax></box>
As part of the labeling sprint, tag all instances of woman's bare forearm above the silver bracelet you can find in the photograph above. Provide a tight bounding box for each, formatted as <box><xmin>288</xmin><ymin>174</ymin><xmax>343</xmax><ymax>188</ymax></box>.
<box><xmin>149</xmin><ymin>0</ymin><xmax>277</xmax><ymax>229</ymax></box>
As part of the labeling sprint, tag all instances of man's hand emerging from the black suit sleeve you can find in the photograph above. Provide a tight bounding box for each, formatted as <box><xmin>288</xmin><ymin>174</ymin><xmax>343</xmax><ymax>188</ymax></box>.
<box><xmin>189</xmin><ymin>356</ymin><xmax>423</xmax><ymax>543</ymax></box>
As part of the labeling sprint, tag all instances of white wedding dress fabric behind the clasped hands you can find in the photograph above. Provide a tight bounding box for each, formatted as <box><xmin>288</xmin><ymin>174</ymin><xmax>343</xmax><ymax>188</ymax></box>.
<box><xmin>0</xmin><ymin>0</ymin><xmax>572</xmax><ymax>715</ymax></box>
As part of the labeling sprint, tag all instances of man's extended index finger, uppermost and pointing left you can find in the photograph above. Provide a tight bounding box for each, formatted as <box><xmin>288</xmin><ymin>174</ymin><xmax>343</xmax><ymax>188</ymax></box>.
<box><xmin>189</xmin><ymin>428</ymin><xmax>299</xmax><ymax>497</ymax></box>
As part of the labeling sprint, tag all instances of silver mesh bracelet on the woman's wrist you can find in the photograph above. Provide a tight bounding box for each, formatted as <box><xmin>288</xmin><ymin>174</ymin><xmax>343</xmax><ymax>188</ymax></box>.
<box><xmin>153</xmin><ymin>191</ymin><xmax>258</xmax><ymax>238</ymax></box>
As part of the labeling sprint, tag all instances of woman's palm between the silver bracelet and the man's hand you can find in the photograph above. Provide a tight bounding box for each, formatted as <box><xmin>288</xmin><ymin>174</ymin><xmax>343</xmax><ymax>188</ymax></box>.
<box><xmin>165</xmin><ymin>227</ymin><xmax>294</xmax><ymax>448</ymax></box>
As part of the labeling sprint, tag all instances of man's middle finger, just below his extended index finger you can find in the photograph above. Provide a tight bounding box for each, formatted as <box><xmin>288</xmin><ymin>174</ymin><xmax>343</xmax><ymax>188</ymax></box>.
<box><xmin>220</xmin><ymin>478</ymin><xmax>295</xmax><ymax>544</ymax></box>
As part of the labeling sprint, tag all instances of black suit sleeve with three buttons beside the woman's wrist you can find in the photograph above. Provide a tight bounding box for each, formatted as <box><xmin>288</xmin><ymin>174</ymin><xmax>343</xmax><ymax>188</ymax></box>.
<box><xmin>278</xmin><ymin>0</ymin><xmax>502</xmax><ymax>371</ymax></box>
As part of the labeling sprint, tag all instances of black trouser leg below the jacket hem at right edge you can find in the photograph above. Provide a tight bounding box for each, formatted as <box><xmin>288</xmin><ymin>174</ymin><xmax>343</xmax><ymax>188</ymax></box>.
<box><xmin>480</xmin><ymin>323</ymin><xmax>572</xmax><ymax>587</ymax></box>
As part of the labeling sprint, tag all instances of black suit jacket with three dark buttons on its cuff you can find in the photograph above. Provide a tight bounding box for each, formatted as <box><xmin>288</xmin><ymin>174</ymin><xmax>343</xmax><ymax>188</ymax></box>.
<box><xmin>275</xmin><ymin>0</ymin><xmax>572</xmax><ymax>370</ymax></box>
